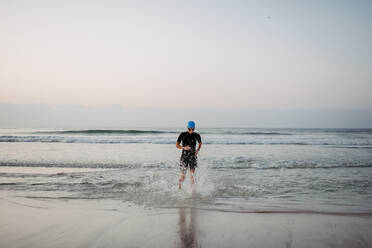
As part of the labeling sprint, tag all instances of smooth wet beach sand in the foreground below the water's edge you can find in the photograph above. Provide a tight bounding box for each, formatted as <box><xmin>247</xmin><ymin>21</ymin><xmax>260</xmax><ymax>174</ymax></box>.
<box><xmin>0</xmin><ymin>191</ymin><xmax>372</xmax><ymax>248</ymax></box>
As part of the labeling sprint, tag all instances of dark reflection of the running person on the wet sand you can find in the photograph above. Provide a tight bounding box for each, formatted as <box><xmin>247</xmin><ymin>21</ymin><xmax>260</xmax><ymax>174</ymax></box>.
<box><xmin>178</xmin><ymin>208</ymin><xmax>198</xmax><ymax>248</ymax></box>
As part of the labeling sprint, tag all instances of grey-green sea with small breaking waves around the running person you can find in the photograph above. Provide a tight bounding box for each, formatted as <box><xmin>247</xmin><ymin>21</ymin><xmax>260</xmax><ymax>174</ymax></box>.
<box><xmin>0</xmin><ymin>128</ymin><xmax>372</xmax><ymax>215</ymax></box>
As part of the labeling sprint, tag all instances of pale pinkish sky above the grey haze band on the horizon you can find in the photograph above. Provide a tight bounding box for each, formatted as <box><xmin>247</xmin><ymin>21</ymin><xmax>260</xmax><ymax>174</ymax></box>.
<box><xmin>0</xmin><ymin>0</ymin><xmax>372</xmax><ymax>110</ymax></box>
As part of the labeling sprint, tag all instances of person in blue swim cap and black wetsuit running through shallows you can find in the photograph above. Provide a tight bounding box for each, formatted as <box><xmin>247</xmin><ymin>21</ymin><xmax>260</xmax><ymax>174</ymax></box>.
<box><xmin>176</xmin><ymin>121</ymin><xmax>202</xmax><ymax>189</ymax></box>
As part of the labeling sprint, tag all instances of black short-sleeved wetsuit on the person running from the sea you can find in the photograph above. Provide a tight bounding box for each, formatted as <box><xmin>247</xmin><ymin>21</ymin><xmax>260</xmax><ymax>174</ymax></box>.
<box><xmin>177</xmin><ymin>132</ymin><xmax>201</xmax><ymax>169</ymax></box>
